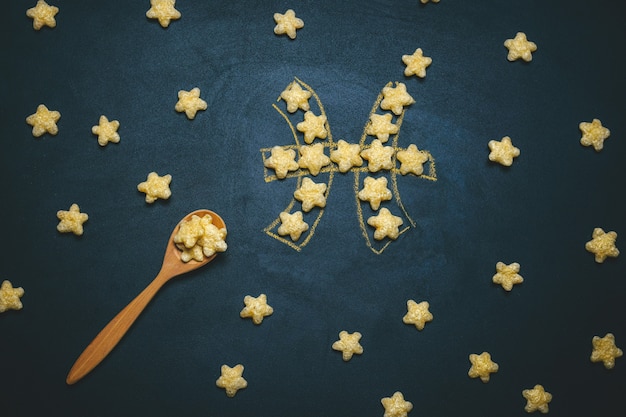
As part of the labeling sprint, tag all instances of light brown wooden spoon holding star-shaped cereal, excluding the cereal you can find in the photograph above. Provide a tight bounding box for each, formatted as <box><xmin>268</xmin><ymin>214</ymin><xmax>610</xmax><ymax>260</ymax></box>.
<box><xmin>65</xmin><ymin>210</ymin><xmax>226</xmax><ymax>385</ymax></box>
